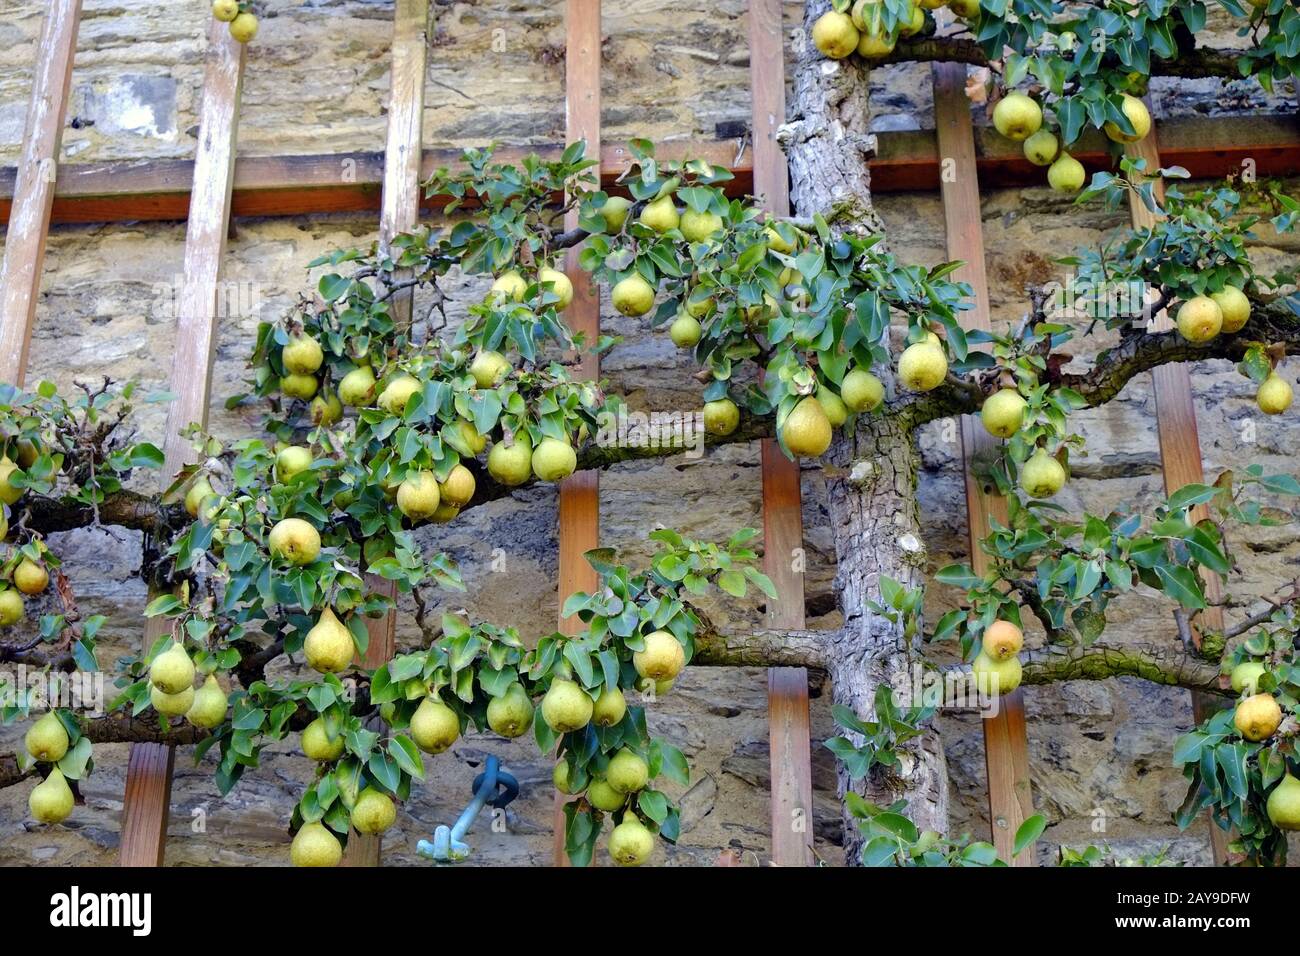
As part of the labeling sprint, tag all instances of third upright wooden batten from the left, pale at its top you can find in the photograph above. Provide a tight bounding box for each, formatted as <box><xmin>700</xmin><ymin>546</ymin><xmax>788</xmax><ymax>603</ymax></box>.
<box><xmin>343</xmin><ymin>0</ymin><xmax>429</xmax><ymax>866</ymax></box>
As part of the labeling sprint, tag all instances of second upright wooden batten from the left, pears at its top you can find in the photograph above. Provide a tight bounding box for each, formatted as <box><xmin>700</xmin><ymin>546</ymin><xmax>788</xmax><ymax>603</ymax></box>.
<box><xmin>118</xmin><ymin>20</ymin><xmax>244</xmax><ymax>866</ymax></box>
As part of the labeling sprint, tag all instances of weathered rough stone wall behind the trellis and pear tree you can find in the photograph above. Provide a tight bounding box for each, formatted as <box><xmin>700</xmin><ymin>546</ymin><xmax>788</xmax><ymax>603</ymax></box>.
<box><xmin>0</xmin><ymin>0</ymin><xmax>1300</xmax><ymax>865</ymax></box>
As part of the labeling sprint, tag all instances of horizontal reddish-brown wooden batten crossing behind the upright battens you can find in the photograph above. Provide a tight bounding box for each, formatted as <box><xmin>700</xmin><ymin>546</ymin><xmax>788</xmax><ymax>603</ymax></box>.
<box><xmin>0</xmin><ymin>116</ymin><xmax>1300</xmax><ymax>224</ymax></box>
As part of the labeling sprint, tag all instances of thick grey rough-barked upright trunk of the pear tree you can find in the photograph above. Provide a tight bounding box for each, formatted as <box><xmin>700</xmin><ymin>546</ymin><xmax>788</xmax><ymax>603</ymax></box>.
<box><xmin>781</xmin><ymin>0</ymin><xmax>948</xmax><ymax>862</ymax></box>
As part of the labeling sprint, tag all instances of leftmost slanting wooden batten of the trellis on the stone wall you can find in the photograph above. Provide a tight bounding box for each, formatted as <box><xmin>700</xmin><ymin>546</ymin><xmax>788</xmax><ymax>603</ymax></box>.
<box><xmin>0</xmin><ymin>0</ymin><xmax>81</xmax><ymax>385</ymax></box>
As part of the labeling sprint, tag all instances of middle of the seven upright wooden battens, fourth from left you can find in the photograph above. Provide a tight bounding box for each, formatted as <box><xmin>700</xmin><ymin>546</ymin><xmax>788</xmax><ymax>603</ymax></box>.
<box><xmin>553</xmin><ymin>0</ymin><xmax>601</xmax><ymax>866</ymax></box>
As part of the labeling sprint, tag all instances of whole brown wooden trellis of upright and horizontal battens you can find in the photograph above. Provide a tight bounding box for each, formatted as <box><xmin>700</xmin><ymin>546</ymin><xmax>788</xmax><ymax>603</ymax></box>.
<box><xmin>0</xmin><ymin>0</ymin><xmax>1284</xmax><ymax>865</ymax></box>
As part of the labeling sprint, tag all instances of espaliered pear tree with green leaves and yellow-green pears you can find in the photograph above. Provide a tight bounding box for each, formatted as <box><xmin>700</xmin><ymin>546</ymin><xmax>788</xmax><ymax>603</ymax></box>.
<box><xmin>0</xmin><ymin>0</ymin><xmax>1300</xmax><ymax>866</ymax></box>
